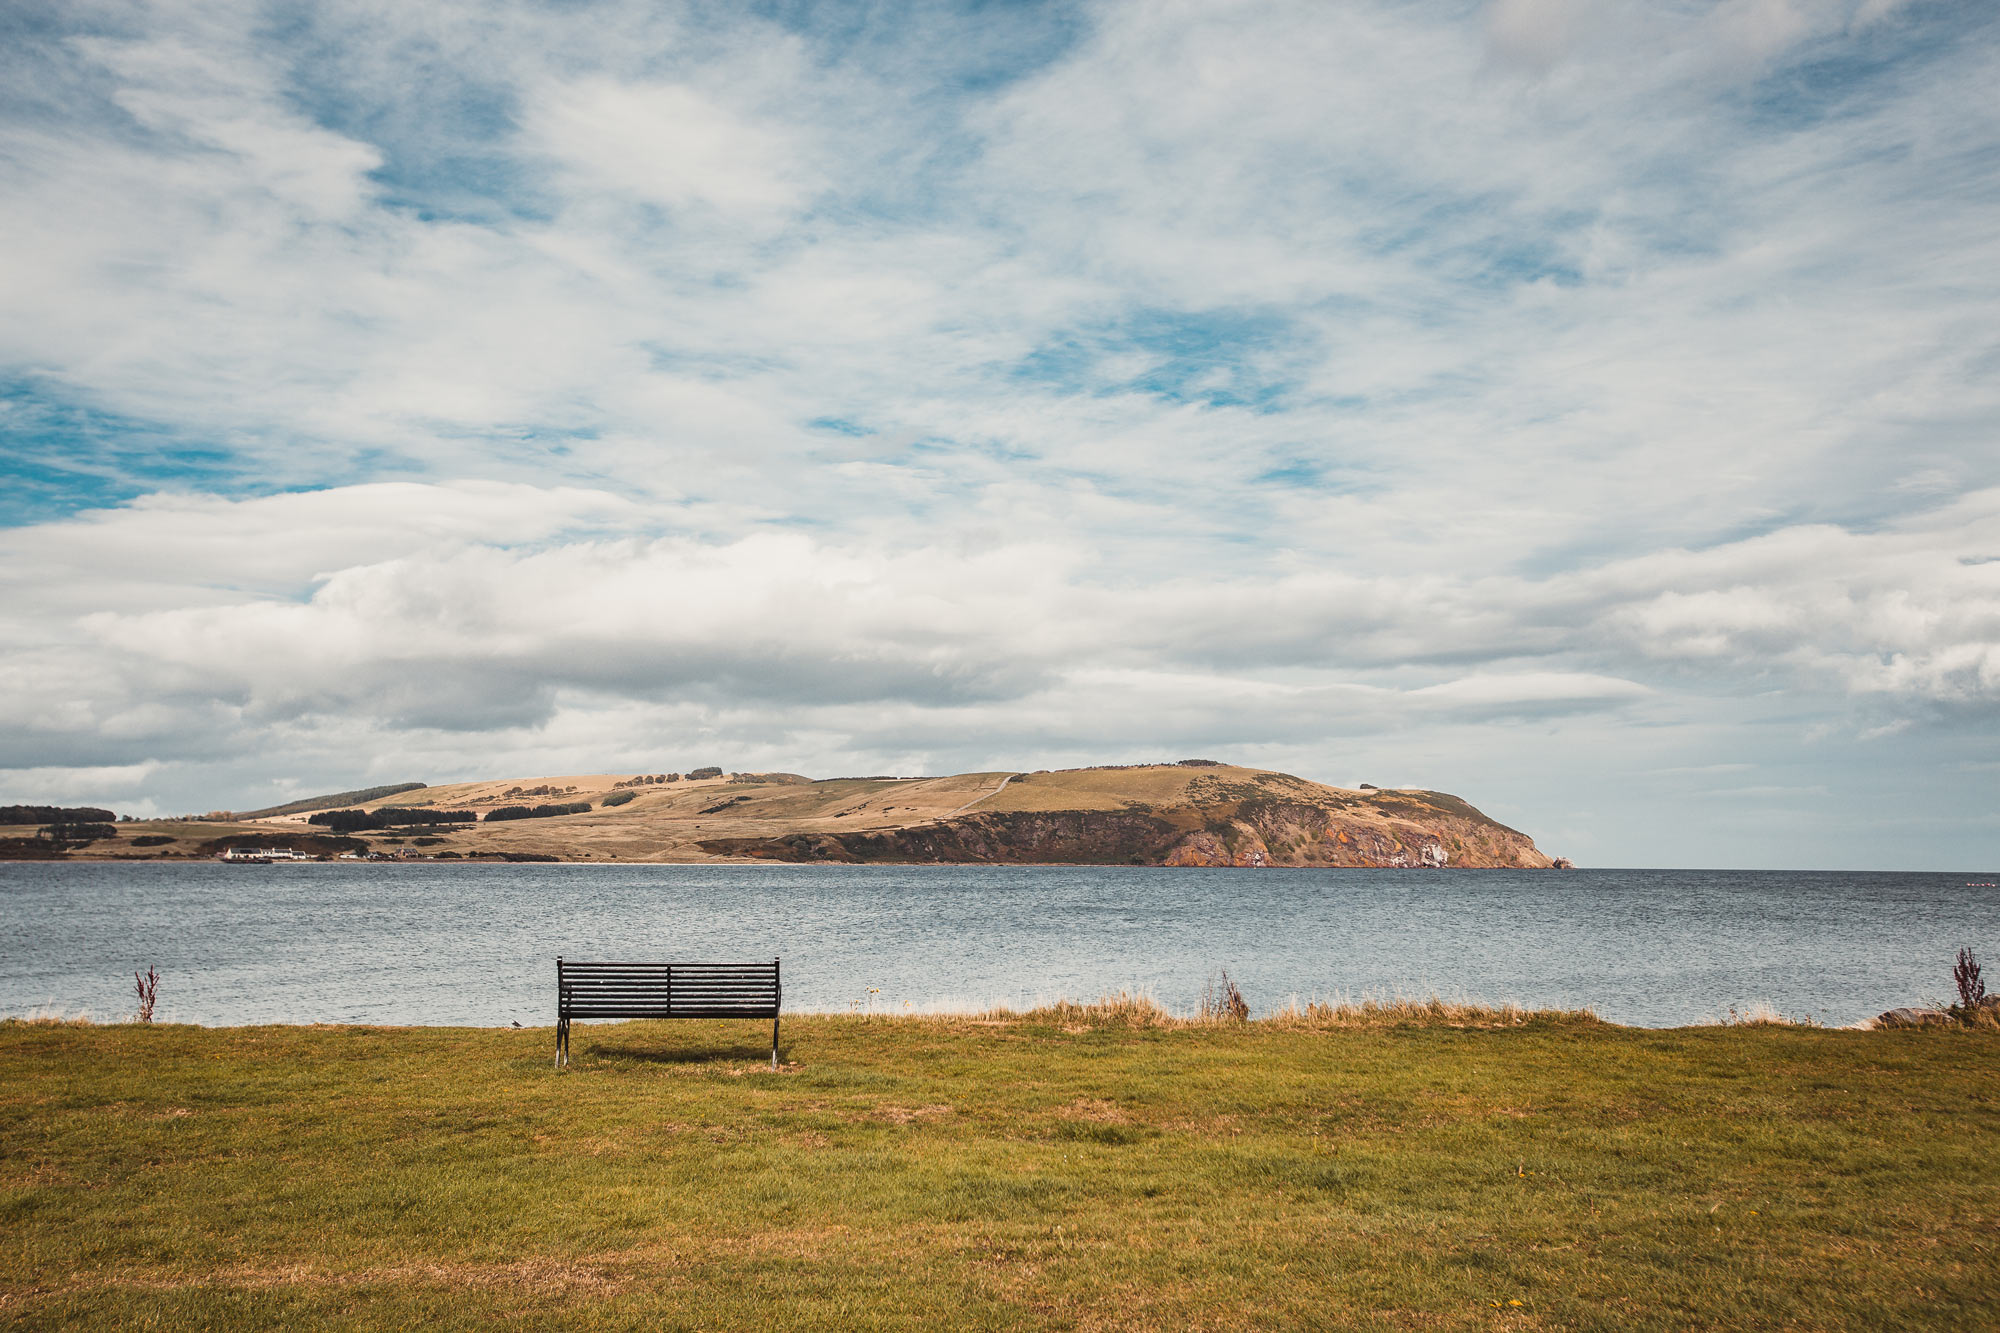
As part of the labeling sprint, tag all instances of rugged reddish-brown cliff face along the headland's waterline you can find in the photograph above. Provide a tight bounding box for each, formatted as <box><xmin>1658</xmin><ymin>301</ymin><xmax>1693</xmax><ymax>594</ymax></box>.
<box><xmin>702</xmin><ymin>779</ymin><xmax>1552</xmax><ymax>869</ymax></box>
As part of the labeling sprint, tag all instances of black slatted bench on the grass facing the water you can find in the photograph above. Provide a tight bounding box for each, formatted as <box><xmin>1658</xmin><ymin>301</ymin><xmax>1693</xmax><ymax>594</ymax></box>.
<box><xmin>556</xmin><ymin>955</ymin><xmax>784</xmax><ymax>1069</ymax></box>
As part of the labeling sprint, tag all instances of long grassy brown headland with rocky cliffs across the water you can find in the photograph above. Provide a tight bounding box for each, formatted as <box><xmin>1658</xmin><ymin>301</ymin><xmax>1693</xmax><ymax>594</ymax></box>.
<box><xmin>0</xmin><ymin>763</ymin><xmax>1550</xmax><ymax>867</ymax></box>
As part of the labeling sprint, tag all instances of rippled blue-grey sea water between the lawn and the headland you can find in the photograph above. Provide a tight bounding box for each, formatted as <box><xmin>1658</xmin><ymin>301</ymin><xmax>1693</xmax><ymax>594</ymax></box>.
<box><xmin>0</xmin><ymin>863</ymin><xmax>2000</xmax><ymax>1027</ymax></box>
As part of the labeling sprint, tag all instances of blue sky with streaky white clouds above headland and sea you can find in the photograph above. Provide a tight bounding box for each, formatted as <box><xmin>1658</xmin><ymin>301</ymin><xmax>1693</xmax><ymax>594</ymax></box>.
<box><xmin>0</xmin><ymin>0</ymin><xmax>2000</xmax><ymax>871</ymax></box>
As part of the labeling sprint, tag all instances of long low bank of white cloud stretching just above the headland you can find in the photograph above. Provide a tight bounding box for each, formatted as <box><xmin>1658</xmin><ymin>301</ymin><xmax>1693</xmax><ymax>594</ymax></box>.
<box><xmin>8</xmin><ymin>486</ymin><xmax>2000</xmax><ymax>780</ymax></box>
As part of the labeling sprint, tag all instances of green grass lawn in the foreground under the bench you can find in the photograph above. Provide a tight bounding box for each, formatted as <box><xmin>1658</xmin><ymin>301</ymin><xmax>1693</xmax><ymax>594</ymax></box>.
<box><xmin>0</xmin><ymin>1007</ymin><xmax>2000</xmax><ymax>1329</ymax></box>
